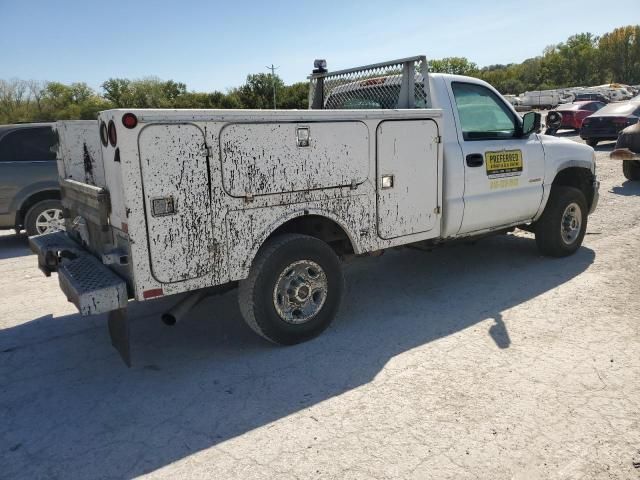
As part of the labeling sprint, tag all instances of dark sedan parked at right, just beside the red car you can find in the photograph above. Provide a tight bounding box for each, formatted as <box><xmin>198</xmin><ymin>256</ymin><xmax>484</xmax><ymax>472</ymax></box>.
<box><xmin>580</xmin><ymin>101</ymin><xmax>640</xmax><ymax>147</ymax></box>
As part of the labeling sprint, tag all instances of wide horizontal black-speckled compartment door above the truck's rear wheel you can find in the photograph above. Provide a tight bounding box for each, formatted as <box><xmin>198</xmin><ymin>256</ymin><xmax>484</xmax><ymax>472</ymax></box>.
<box><xmin>220</xmin><ymin>122</ymin><xmax>369</xmax><ymax>197</ymax></box>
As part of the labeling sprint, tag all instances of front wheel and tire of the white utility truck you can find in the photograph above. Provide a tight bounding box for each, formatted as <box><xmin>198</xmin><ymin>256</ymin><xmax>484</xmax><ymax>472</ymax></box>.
<box><xmin>534</xmin><ymin>186</ymin><xmax>588</xmax><ymax>257</ymax></box>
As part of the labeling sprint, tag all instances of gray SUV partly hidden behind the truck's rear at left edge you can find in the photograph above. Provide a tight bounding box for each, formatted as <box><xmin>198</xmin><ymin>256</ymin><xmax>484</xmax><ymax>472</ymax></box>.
<box><xmin>0</xmin><ymin>123</ymin><xmax>63</xmax><ymax>235</ymax></box>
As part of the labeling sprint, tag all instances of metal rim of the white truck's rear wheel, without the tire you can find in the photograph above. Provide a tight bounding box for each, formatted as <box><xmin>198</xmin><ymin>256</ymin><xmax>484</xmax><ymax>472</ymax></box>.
<box><xmin>273</xmin><ymin>260</ymin><xmax>329</xmax><ymax>325</ymax></box>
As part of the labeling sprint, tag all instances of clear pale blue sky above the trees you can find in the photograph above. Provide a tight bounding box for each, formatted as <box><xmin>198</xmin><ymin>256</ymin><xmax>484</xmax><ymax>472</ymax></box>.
<box><xmin>0</xmin><ymin>0</ymin><xmax>640</xmax><ymax>91</ymax></box>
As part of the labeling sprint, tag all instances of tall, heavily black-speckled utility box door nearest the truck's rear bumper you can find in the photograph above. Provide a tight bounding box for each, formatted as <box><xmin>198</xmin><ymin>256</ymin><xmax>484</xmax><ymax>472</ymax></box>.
<box><xmin>138</xmin><ymin>124</ymin><xmax>216</xmax><ymax>283</ymax></box>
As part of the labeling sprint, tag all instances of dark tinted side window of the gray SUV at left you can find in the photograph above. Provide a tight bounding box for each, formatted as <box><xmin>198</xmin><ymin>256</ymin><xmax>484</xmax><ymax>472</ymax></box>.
<box><xmin>0</xmin><ymin>127</ymin><xmax>56</xmax><ymax>162</ymax></box>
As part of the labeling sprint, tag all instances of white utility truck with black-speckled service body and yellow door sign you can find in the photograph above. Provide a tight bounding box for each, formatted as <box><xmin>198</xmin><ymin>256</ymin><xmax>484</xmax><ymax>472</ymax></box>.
<box><xmin>30</xmin><ymin>56</ymin><xmax>598</xmax><ymax>364</ymax></box>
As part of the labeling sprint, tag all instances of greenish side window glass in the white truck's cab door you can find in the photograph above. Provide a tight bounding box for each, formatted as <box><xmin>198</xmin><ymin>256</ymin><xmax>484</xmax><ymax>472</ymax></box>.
<box><xmin>451</xmin><ymin>82</ymin><xmax>518</xmax><ymax>140</ymax></box>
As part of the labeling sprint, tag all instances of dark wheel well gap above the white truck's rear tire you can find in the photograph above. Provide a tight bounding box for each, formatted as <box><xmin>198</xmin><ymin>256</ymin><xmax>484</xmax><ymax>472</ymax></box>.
<box><xmin>267</xmin><ymin>215</ymin><xmax>354</xmax><ymax>256</ymax></box>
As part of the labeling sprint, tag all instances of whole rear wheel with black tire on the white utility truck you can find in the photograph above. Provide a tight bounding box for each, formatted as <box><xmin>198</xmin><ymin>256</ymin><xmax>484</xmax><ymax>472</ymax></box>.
<box><xmin>238</xmin><ymin>234</ymin><xmax>344</xmax><ymax>345</ymax></box>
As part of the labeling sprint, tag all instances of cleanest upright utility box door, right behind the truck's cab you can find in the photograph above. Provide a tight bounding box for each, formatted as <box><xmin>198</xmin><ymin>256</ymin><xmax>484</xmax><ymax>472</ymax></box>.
<box><xmin>376</xmin><ymin>120</ymin><xmax>438</xmax><ymax>239</ymax></box>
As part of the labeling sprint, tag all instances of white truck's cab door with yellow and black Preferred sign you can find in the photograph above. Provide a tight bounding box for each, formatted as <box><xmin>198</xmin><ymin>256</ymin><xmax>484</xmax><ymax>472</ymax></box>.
<box><xmin>451</xmin><ymin>82</ymin><xmax>544</xmax><ymax>233</ymax></box>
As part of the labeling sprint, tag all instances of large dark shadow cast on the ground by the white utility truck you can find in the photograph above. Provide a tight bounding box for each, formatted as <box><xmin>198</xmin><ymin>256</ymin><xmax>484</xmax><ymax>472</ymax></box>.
<box><xmin>0</xmin><ymin>235</ymin><xmax>595</xmax><ymax>479</ymax></box>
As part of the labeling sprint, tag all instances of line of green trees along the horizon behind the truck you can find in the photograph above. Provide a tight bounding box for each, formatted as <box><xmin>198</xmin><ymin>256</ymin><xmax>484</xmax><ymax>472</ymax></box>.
<box><xmin>0</xmin><ymin>25</ymin><xmax>640</xmax><ymax>124</ymax></box>
